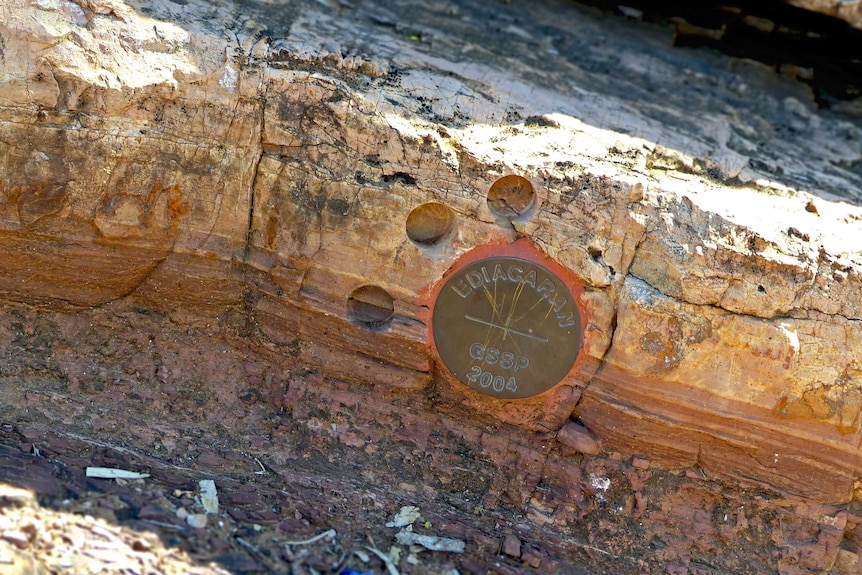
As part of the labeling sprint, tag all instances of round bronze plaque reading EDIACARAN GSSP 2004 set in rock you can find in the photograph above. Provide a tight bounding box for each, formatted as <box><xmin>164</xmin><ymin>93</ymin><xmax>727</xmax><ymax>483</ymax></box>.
<box><xmin>432</xmin><ymin>256</ymin><xmax>581</xmax><ymax>399</ymax></box>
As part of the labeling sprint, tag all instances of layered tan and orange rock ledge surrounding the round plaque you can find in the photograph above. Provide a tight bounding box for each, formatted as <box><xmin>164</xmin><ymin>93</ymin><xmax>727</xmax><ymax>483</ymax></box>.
<box><xmin>0</xmin><ymin>0</ymin><xmax>862</xmax><ymax>532</ymax></box>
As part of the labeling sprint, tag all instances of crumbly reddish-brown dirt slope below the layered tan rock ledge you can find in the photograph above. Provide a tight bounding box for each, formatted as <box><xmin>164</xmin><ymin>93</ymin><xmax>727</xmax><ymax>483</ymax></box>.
<box><xmin>0</xmin><ymin>301</ymin><xmax>858</xmax><ymax>575</ymax></box>
